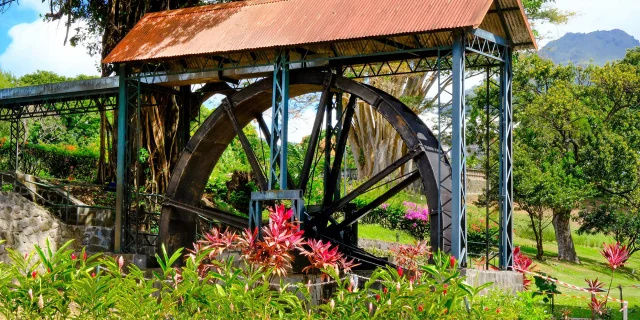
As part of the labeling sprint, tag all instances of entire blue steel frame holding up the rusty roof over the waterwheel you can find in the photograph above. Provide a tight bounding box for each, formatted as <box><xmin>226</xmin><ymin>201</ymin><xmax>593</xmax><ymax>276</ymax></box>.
<box><xmin>0</xmin><ymin>25</ymin><xmax>513</xmax><ymax>269</ymax></box>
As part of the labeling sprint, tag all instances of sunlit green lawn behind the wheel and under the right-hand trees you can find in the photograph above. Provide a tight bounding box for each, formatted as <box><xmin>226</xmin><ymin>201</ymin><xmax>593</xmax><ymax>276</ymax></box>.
<box><xmin>359</xmin><ymin>205</ymin><xmax>640</xmax><ymax>319</ymax></box>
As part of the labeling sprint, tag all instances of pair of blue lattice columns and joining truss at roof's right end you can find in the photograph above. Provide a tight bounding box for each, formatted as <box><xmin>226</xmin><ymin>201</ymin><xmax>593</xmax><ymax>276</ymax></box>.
<box><xmin>436</xmin><ymin>29</ymin><xmax>513</xmax><ymax>269</ymax></box>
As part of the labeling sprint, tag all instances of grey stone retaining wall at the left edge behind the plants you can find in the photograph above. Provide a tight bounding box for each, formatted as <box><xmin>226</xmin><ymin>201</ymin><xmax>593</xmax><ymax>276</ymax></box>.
<box><xmin>0</xmin><ymin>192</ymin><xmax>113</xmax><ymax>262</ymax></box>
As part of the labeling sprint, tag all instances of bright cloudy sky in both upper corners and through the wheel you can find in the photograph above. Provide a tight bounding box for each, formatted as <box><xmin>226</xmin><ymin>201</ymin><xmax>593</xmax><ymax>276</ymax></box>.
<box><xmin>0</xmin><ymin>0</ymin><xmax>640</xmax><ymax>141</ymax></box>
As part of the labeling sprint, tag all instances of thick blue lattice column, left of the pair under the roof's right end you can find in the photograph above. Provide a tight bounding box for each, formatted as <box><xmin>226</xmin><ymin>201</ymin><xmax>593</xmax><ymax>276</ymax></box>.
<box><xmin>451</xmin><ymin>31</ymin><xmax>467</xmax><ymax>267</ymax></box>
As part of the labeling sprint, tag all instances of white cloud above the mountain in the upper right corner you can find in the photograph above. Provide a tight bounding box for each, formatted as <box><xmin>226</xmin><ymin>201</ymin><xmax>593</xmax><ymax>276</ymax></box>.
<box><xmin>536</xmin><ymin>0</ymin><xmax>640</xmax><ymax>44</ymax></box>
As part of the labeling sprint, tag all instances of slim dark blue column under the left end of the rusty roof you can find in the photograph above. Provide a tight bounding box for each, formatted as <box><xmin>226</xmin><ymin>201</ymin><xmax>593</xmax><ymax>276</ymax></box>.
<box><xmin>113</xmin><ymin>64</ymin><xmax>129</xmax><ymax>253</ymax></box>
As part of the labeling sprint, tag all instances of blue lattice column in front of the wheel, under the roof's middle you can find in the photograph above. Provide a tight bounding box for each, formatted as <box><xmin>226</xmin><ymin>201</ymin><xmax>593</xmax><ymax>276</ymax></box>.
<box><xmin>269</xmin><ymin>50</ymin><xmax>289</xmax><ymax>190</ymax></box>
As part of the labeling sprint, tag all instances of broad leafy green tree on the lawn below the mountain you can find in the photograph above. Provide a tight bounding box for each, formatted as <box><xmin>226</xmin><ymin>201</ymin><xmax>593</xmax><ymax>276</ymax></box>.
<box><xmin>514</xmin><ymin>51</ymin><xmax>640</xmax><ymax>261</ymax></box>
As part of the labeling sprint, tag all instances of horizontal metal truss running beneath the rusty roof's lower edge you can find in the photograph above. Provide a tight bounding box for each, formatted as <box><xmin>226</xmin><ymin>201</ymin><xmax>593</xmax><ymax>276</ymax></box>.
<box><xmin>125</xmin><ymin>29</ymin><xmax>508</xmax><ymax>85</ymax></box>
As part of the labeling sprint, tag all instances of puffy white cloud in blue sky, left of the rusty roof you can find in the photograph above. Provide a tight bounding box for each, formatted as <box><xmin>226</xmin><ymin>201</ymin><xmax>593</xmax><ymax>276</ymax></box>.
<box><xmin>0</xmin><ymin>19</ymin><xmax>99</xmax><ymax>77</ymax></box>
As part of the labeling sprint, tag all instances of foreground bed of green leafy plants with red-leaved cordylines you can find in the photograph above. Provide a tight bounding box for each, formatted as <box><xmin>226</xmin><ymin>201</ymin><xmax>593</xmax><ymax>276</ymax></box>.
<box><xmin>0</xmin><ymin>208</ymin><xmax>549</xmax><ymax>319</ymax></box>
